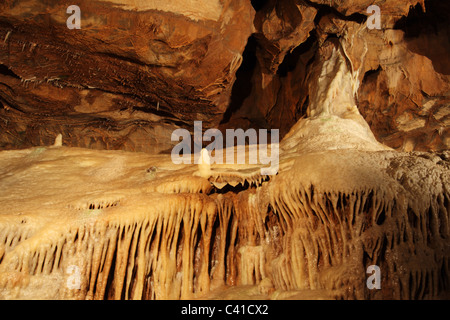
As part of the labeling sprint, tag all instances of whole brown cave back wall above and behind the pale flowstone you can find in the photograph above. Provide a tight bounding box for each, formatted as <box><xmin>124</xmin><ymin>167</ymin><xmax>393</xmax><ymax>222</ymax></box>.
<box><xmin>0</xmin><ymin>0</ymin><xmax>450</xmax><ymax>152</ymax></box>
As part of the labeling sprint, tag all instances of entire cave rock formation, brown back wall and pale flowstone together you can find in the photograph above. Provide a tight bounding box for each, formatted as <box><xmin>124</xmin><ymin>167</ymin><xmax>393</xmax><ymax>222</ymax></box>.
<box><xmin>0</xmin><ymin>0</ymin><xmax>450</xmax><ymax>299</ymax></box>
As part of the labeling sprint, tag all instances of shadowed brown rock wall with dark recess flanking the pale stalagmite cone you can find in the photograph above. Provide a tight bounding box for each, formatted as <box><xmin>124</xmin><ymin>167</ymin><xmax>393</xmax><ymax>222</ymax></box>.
<box><xmin>223</xmin><ymin>1</ymin><xmax>450</xmax><ymax>151</ymax></box>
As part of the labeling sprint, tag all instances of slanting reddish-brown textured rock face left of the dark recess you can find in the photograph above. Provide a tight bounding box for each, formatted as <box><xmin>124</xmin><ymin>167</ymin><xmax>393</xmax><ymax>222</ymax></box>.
<box><xmin>0</xmin><ymin>0</ymin><xmax>254</xmax><ymax>152</ymax></box>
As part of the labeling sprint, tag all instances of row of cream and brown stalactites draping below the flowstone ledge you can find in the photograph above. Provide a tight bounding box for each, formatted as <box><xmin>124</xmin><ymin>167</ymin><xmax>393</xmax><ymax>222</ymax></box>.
<box><xmin>0</xmin><ymin>176</ymin><xmax>449</xmax><ymax>299</ymax></box>
